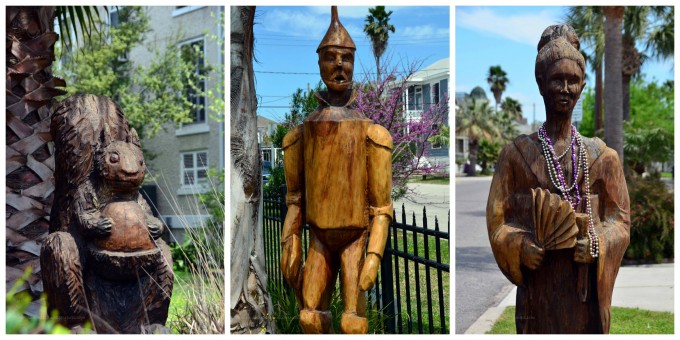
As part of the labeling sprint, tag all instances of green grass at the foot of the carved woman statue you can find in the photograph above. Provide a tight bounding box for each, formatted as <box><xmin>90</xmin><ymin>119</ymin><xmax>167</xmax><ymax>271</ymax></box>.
<box><xmin>487</xmin><ymin>307</ymin><xmax>674</xmax><ymax>334</ymax></box>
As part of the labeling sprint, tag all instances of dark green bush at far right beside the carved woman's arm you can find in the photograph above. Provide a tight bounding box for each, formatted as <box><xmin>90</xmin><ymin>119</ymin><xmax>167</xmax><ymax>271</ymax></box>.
<box><xmin>625</xmin><ymin>174</ymin><xmax>674</xmax><ymax>262</ymax></box>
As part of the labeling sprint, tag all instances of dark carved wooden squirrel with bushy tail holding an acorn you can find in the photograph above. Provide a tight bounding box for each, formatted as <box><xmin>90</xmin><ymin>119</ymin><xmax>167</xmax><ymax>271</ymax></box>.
<box><xmin>40</xmin><ymin>95</ymin><xmax>173</xmax><ymax>333</ymax></box>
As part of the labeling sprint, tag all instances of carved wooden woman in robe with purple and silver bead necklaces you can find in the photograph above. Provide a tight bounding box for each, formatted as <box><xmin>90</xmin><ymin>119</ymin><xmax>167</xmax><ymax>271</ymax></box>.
<box><xmin>486</xmin><ymin>25</ymin><xmax>630</xmax><ymax>333</ymax></box>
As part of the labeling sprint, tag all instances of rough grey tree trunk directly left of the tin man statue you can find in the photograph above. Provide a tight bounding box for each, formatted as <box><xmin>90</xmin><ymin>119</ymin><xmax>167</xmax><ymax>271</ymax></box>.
<box><xmin>230</xmin><ymin>6</ymin><xmax>274</xmax><ymax>333</ymax></box>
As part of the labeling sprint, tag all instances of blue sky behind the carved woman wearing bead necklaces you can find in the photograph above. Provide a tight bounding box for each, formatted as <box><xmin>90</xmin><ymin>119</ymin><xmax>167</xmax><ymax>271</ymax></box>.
<box><xmin>454</xmin><ymin>6</ymin><xmax>674</xmax><ymax>122</ymax></box>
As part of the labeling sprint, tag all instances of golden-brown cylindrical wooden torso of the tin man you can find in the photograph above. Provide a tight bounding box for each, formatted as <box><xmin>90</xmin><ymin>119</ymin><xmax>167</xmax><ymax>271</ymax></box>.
<box><xmin>303</xmin><ymin>99</ymin><xmax>373</xmax><ymax>229</ymax></box>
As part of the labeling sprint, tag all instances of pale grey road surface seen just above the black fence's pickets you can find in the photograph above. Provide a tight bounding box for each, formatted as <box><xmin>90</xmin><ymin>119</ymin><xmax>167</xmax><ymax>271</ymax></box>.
<box><xmin>394</xmin><ymin>183</ymin><xmax>451</xmax><ymax>231</ymax></box>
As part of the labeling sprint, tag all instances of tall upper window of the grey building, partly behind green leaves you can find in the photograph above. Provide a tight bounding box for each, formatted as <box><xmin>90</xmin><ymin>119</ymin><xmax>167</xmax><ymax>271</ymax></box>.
<box><xmin>180</xmin><ymin>38</ymin><xmax>208</xmax><ymax>124</ymax></box>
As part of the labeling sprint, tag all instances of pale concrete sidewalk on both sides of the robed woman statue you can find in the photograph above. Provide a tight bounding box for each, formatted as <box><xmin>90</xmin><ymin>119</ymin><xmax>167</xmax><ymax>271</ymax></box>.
<box><xmin>465</xmin><ymin>263</ymin><xmax>674</xmax><ymax>334</ymax></box>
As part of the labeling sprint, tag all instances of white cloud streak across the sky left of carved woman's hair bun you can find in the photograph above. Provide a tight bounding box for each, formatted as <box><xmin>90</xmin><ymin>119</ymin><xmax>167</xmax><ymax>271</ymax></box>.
<box><xmin>456</xmin><ymin>7</ymin><xmax>559</xmax><ymax>46</ymax></box>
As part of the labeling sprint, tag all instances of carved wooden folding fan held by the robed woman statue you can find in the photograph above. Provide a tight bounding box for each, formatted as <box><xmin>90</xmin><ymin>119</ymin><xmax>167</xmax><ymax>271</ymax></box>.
<box><xmin>531</xmin><ymin>188</ymin><xmax>578</xmax><ymax>250</ymax></box>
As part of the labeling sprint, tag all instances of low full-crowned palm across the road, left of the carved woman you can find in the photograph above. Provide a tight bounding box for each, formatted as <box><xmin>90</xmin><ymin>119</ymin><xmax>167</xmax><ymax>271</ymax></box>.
<box><xmin>456</xmin><ymin>98</ymin><xmax>500</xmax><ymax>176</ymax></box>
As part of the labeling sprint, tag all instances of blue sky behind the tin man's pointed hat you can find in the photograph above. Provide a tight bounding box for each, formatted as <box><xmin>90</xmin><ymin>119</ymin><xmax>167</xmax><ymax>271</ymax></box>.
<box><xmin>254</xmin><ymin>6</ymin><xmax>451</xmax><ymax>121</ymax></box>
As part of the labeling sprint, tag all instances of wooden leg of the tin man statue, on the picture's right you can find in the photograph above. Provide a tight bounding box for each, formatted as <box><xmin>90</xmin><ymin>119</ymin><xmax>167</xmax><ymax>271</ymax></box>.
<box><xmin>340</xmin><ymin>231</ymin><xmax>368</xmax><ymax>334</ymax></box>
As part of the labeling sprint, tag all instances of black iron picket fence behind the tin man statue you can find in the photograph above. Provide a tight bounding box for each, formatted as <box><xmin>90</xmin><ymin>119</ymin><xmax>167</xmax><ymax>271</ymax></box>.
<box><xmin>263</xmin><ymin>189</ymin><xmax>450</xmax><ymax>334</ymax></box>
